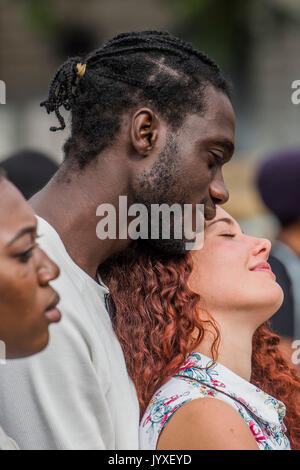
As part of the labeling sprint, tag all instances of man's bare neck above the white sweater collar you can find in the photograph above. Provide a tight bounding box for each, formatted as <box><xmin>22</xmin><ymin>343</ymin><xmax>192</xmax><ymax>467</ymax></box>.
<box><xmin>30</xmin><ymin>162</ymin><xmax>128</xmax><ymax>279</ymax></box>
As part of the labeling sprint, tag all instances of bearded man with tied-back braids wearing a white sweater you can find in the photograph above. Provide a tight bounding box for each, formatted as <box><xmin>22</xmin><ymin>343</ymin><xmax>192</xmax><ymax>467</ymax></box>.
<box><xmin>0</xmin><ymin>31</ymin><xmax>235</xmax><ymax>449</ymax></box>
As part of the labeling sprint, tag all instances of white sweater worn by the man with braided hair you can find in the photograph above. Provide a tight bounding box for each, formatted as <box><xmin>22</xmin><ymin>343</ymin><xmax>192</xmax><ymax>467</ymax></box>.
<box><xmin>0</xmin><ymin>218</ymin><xmax>139</xmax><ymax>449</ymax></box>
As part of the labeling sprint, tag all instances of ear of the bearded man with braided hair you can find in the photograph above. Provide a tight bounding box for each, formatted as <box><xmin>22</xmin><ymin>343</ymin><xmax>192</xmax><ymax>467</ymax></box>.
<box><xmin>130</xmin><ymin>108</ymin><xmax>159</xmax><ymax>156</ymax></box>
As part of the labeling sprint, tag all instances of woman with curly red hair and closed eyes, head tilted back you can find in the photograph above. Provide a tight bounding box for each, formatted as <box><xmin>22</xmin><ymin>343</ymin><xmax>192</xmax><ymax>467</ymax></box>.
<box><xmin>102</xmin><ymin>208</ymin><xmax>300</xmax><ymax>450</ymax></box>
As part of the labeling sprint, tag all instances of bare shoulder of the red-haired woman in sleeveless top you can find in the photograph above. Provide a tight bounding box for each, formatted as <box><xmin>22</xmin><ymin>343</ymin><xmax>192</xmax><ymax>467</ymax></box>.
<box><xmin>157</xmin><ymin>397</ymin><xmax>258</xmax><ymax>450</ymax></box>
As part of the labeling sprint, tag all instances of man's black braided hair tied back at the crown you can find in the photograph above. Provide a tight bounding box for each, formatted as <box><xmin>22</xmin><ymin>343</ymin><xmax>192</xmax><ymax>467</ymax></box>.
<box><xmin>41</xmin><ymin>31</ymin><xmax>230</xmax><ymax>168</ymax></box>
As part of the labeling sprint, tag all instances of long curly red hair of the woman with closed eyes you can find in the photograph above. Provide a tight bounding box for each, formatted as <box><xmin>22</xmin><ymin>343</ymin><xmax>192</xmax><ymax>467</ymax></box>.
<box><xmin>101</xmin><ymin>243</ymin><xmax>300</xmax><ymax>449</ymax></box>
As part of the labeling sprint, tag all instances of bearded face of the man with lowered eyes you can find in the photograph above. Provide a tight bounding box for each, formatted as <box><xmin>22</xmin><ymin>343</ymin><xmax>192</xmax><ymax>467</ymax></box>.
<box><xmin>135</xmin><ymin>87</ymin><xmax>235</xmax><ymax>255</ymax></box>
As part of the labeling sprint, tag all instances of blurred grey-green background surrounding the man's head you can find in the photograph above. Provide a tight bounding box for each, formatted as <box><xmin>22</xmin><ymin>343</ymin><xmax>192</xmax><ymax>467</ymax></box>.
<box><xmin>0</xmin><ymin>0</ymin><xmax>300</xmax><ymax>234</ymax></box>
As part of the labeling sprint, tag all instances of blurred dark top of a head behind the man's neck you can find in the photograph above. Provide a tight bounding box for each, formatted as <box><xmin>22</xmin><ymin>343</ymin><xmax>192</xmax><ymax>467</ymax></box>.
<box><xmin>1</xmin><ymin>149</ymin><xmax>58</xmax><ymax>199</ymax></box>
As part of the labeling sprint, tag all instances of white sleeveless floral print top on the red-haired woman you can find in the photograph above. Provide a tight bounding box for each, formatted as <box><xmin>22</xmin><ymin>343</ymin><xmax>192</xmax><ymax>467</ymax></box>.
<box><xmin>140</xmin><ymin>352</ymin><xmax>290</xmax><ymax>450</ymax></box>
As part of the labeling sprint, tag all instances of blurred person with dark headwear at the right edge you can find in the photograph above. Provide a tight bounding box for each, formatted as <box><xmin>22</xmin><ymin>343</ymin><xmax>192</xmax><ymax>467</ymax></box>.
<box><xmin>256</xmin><ymin>149</ymin><xmax>300</xmax><ymax>357</ymax></box>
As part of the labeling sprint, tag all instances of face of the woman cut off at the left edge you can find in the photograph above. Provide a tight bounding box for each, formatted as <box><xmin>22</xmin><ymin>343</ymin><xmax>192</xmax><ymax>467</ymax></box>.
<box><xmin>0</xmin><ymin>180</ymin><xmax>60</xmax><ymax>358</ymax></box>
